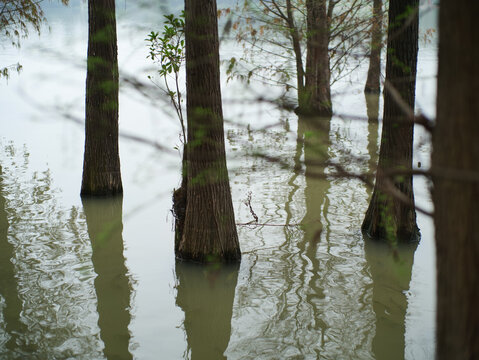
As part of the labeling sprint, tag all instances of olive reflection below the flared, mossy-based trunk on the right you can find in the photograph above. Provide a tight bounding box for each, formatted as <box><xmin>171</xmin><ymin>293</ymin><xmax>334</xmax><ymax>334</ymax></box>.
<box><xmin>364</xmin><ymin>239</ymin><xmax>418</xmax><ymax>360</ymax></box>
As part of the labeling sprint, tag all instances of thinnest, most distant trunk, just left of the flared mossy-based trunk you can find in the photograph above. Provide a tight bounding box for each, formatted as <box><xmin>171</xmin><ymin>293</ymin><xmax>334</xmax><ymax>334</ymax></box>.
<box><xmin>364</xmin><ymin>0</ymin><xmax>383</xmax><ymax>93</ymax></box>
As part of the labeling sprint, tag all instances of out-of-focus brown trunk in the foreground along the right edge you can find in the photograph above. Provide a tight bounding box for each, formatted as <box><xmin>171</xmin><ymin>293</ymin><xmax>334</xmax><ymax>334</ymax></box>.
<box><xmin>432</xmin><ymin>0</ymin><xmax>479</xmax><ymax>360</ymax></box>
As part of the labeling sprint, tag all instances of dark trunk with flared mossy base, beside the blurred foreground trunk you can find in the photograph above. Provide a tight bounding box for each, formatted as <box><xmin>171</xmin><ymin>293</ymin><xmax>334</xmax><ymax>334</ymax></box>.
<box><xmin>362</xmin><ymin>0</ymin><xmax>419</xmax><ymax>243</ymax></box>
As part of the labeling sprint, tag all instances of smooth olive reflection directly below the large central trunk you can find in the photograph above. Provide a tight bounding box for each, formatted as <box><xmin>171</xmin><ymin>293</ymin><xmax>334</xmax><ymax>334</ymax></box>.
<box><xmin>176</xmin><ymin>261</ymin><xmax>239</xmax><ymax>360</ymax></box>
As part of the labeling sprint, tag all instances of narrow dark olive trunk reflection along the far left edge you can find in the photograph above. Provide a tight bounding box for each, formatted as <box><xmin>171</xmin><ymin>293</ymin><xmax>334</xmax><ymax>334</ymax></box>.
<box><xmin>0</xmin><ymin>166</ymin><xmax>34</xmax><ymax>355</ymax></box>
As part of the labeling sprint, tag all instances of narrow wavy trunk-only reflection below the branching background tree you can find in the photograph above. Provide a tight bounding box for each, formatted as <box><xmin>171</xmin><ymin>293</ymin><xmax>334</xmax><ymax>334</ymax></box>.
<box><xmin>279</xmin><ymin>116</ymin><xmax>331</xmax><ymax>354</ymax></box>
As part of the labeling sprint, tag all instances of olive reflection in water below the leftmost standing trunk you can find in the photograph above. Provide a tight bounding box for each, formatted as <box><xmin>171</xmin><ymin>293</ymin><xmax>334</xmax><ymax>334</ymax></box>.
<box><xmin>82</xmin><ymin>196</ymin><xmax>132</xmax><ymax>360</ymax></box>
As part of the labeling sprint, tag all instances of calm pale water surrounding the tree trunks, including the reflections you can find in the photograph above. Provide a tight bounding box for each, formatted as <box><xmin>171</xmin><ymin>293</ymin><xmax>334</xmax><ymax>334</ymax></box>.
<box><xmin>0</xmin><ymin>1</ymin><xmax>436</xmax><ymax>359</ymax></box>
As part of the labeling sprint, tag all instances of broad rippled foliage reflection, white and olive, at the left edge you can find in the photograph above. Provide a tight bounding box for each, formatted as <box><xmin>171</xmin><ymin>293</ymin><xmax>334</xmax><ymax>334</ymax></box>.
<box><xmin>0</xmin><ymin>145</ymin><xmax>101</xmax><ymax>359</ymax></box>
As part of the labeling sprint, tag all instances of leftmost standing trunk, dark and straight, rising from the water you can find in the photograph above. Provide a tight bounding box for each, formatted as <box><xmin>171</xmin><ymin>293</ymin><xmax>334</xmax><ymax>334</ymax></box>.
<box><xmin>81</xmin><ymin>0</ymin><xmax>123</xmax><ymax>196</ymax></box>
